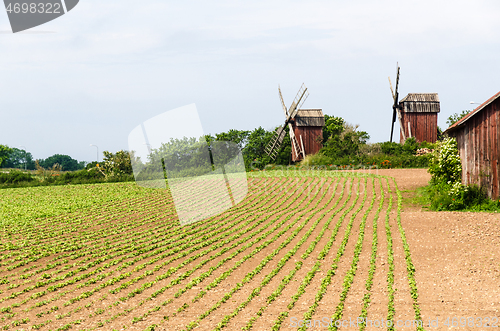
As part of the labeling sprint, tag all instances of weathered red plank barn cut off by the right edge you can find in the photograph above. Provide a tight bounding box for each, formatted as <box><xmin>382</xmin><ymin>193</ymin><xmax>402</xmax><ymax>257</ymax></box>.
<box><xmin>444</xmin><ymin>92</ymin><xmax>500</xmax><ymax>199</ymax></box>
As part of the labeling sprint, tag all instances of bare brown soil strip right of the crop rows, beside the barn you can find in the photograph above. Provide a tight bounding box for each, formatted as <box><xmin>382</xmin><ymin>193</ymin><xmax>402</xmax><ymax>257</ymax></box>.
<box><xmin>379</xmin><ymin>169</ymin><xmax>500</xmax><ymax>330</ymax></box>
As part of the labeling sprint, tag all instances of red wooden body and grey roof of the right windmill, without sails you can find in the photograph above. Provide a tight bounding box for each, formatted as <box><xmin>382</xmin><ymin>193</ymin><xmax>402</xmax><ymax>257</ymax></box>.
<box><xmin>399</xmin><ymin>93</ymin><xmax>440</xmax><ymax>143</ymax></box>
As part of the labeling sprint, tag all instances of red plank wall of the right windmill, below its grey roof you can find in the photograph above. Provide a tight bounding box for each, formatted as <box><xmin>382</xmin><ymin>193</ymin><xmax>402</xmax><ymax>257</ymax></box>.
<box><xmin>399</xmin><ymin>112</ymin><xmax>438</xmax><ymax>143</ymax></box>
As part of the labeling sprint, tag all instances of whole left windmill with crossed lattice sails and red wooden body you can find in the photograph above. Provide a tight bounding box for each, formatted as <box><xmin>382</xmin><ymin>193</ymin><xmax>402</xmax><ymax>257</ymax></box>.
<box><xmin>266</xmin><ymin>84</ymin><xmax>325</xmax><ymax>162</ymax></box>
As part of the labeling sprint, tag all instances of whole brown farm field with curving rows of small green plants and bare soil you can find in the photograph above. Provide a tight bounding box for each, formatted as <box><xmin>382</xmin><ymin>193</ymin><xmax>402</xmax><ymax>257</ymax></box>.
<box><xmin>0</xmin><ymin>169</ymin><xmax>500</xmax><ymax>331</ymax></box>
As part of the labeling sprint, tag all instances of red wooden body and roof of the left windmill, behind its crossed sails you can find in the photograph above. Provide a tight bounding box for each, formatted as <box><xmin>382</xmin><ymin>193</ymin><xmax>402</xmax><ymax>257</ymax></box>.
<box><xmin>292</xmin><ymin>109</ymin><xmax>325</xmax><ymax>162</ymax></box>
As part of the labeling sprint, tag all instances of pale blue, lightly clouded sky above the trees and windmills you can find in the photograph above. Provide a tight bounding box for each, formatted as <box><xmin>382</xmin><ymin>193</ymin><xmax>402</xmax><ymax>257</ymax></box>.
<box><xmin>0</xmin><ymin>0</ymin><xmax>500</xmax><ymax>161</ymax></box>
